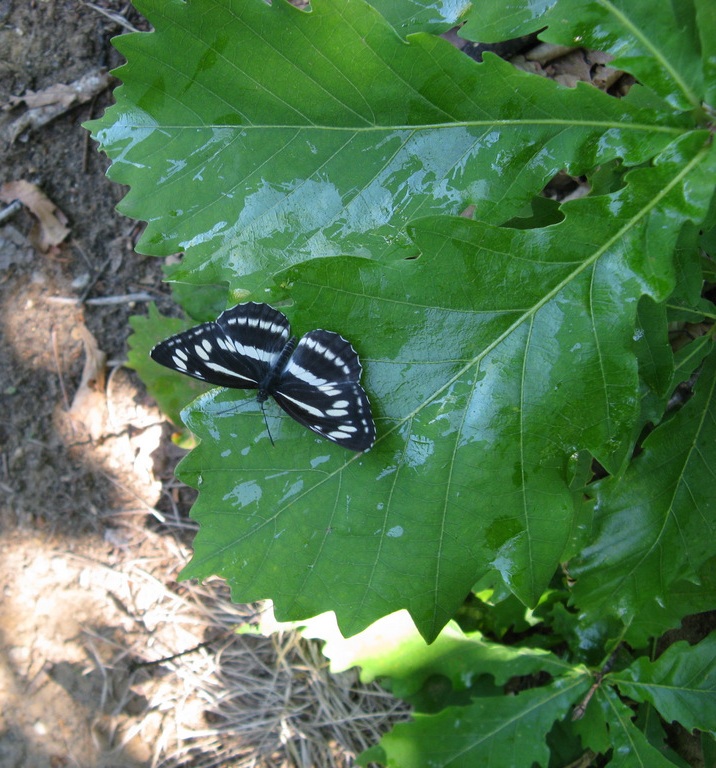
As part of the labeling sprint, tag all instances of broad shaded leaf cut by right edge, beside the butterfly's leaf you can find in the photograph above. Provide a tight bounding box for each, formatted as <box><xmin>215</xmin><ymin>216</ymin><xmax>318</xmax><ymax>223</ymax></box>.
<box><xmin>570</xmin><ymin>354</ymin><xmax>716</xmax><ymax>625</ymax></box>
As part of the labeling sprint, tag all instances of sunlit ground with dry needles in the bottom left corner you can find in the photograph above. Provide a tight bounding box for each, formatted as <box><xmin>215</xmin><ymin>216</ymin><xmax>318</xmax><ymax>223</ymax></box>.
<box><xmin>0</xmin><ymin>532</ymin><xmax>404</xmax><ymax>768</ymax></box>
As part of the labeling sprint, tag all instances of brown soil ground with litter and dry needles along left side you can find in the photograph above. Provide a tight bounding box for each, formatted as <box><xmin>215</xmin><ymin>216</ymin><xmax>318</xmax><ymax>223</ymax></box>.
<box><xmin>0</xmin><ymin>0</ymin><xmax>406</xmax><ymax>768</ymax></box>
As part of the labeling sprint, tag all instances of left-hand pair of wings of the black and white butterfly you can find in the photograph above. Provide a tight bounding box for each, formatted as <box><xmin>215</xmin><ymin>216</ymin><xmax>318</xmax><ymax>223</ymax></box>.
<box><xmin>150</xmin><ymin>301</ymin><xmax>291</xmax><ymax>389</ymax></box>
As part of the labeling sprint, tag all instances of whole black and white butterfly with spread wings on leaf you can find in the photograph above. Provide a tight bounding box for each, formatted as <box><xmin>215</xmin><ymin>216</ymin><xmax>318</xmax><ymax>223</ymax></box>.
<box><xmin>150</xmin><ymin>301</ymin><xmax>375</xmax><ymax>451</ymax></box>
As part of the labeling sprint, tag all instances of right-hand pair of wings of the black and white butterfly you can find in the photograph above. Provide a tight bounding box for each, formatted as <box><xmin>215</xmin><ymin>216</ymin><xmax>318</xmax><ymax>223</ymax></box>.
<box><xmin>271</xmin><ymin>330</ymin><xmax>375</xmax><ymax>451</ymax></box>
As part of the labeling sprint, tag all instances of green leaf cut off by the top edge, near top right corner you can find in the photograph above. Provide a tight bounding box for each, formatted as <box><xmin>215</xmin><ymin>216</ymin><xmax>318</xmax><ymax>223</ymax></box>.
<box><xmin>461</xmin><ymin>0</ymin><xmax>714</xmax><ymax>110</ymax></box>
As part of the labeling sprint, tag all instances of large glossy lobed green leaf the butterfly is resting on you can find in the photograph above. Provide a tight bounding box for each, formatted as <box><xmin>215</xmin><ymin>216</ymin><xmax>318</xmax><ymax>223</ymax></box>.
<box><xmin>180</xmin><ymin>135</ymin><xmax>711</xmax><ymax>639</ymax></box>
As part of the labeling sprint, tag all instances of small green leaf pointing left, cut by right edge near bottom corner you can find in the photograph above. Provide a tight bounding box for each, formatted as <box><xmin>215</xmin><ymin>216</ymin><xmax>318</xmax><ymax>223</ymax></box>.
<box><xmin>609</xmin><ymin>634</ymin><xmax>716</xmax><ymax>731</ymax></box>
